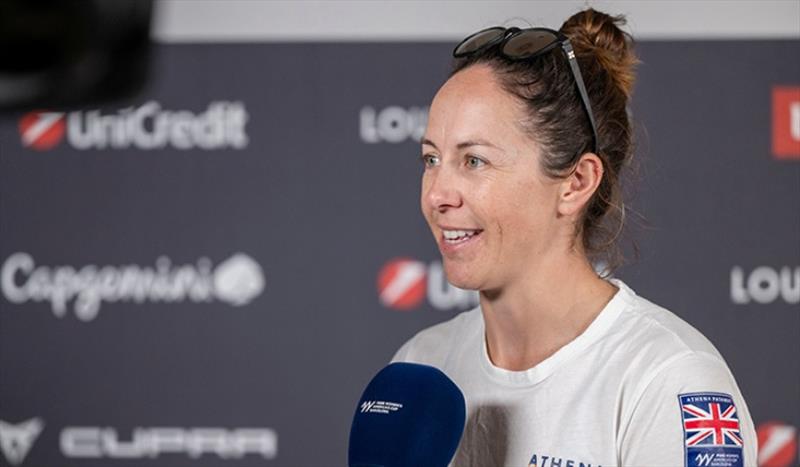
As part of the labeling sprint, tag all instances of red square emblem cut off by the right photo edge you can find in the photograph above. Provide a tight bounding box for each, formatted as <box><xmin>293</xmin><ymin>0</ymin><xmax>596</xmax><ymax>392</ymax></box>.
<box><xmin>772</xmin><ymin>86</ymin><xmax>800</xmax><ymax>159</ymax></box>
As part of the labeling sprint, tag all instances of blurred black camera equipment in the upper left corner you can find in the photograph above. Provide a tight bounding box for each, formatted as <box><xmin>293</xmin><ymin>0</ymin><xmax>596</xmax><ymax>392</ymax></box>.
<box><xmin>0</xmin><ymin>0</ymin><xmax>153</xmax><ymax>112</ymax></box>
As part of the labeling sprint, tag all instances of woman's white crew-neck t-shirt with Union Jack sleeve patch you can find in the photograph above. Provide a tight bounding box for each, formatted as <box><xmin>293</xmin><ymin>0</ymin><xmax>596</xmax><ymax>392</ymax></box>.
<box><xmin>393</xmin><ymin>280</ymin><xmax>756</xmax><ymax>467</ymax></box>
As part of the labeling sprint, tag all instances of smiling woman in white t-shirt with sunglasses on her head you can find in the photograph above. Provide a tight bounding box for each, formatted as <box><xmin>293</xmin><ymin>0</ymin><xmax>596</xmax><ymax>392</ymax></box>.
<box><xmin>394</xmin><ymin>9</ymin><xmax>756</xmax><ymax>467</ymax></box>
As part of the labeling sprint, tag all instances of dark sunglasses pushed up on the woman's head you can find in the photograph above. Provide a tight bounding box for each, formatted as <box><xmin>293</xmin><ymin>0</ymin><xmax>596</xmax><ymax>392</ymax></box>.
<box><xmin>453</xmin><ymin>26</ymin><xmax>600</xmax><ymax>153</ymax></box>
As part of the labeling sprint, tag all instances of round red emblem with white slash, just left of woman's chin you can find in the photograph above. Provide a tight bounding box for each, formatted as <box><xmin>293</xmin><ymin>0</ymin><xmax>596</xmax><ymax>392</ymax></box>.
<box><xmin>378</xmin><ymin>258</ymin><xmax>427</xmax><ymax>310</ymax></box>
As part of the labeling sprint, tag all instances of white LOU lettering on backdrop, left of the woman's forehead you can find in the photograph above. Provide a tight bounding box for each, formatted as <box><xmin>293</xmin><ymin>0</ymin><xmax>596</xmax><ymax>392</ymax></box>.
<box><xmin>359</xmin><ymin>106</ymin><xmax>428</xmax><ymax>143</ymax></box>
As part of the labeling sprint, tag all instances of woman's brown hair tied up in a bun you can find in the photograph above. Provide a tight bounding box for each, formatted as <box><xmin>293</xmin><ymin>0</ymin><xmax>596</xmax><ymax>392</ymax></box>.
<box><xmin>451</xmin><ymin>8</ymin><xmax>638</xmax><ymax>272</ymax></box>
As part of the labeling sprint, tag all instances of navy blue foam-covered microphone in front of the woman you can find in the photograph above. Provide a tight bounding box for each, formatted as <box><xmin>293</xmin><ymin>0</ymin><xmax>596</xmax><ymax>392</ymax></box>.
<box><xmin>348</xmin><ymin>362</ymin><xmax>466</xmax><ymax>467</ymax></box>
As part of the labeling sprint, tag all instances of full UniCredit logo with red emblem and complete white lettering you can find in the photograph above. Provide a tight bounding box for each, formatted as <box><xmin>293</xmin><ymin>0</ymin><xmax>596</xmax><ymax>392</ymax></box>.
<box><xmin>19</xmin><ymin>101</ymin><xmax>249</xmax><ymax>151</ymax></box>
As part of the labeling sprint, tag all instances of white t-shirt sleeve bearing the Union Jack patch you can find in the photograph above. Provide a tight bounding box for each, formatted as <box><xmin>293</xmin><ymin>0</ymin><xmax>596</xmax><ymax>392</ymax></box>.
<box><xmin>619</xmin><ymin>352</ymin><xmax>757</xmax><ymax>467</ymax></box>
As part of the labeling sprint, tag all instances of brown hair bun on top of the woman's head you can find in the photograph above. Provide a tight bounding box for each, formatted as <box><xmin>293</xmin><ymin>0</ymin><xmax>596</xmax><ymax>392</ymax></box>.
<box><xmin>561</xmin><ymin>8</ymin><xmax>638</xmax><ymax>98</ymax></box>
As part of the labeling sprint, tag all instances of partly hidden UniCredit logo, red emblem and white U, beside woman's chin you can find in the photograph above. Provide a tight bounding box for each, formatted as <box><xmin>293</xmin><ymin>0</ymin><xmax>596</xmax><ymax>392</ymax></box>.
<box><xmin>378</xmin><ymin>258</ymin><xmax>478</xmax><ymax>310</ymax></box>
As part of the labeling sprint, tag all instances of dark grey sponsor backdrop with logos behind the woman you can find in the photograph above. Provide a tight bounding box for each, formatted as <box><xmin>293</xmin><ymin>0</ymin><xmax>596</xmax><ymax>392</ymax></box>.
<box><xmin>0</xmin><ymin>40</ymin><xmax>800</xmax><ymax>467</ymax></box>
